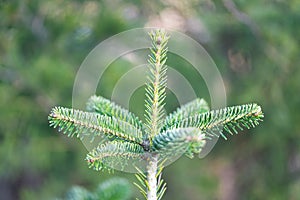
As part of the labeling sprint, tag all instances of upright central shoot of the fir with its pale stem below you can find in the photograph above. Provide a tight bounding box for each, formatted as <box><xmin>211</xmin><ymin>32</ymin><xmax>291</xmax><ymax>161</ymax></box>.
<box><xmin>145</xmin><ymin>30</ymin><xmax>169</xmax><ymax>200</ymax></box>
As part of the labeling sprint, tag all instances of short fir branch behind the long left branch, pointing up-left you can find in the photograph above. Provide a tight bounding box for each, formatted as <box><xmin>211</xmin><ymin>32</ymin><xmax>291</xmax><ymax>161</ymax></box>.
<box><xmin>87</xmin><ymin>95</ymin><xmax>143</xmax><ymax>130</ymax></box>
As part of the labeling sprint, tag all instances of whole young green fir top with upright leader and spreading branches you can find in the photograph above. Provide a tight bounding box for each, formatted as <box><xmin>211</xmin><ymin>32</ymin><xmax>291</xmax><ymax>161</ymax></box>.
<box><xmin>49</xmin><ymin>30</ymin><xmax>263</xmax><ymax>200</ymax></box>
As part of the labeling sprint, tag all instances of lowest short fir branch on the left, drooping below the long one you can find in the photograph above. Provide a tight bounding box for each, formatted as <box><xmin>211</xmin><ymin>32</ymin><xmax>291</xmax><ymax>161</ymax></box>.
<box><xmin>86</xmin><ymin>141</ymin><xmax>144</xmax><ymax>171</ymax></box>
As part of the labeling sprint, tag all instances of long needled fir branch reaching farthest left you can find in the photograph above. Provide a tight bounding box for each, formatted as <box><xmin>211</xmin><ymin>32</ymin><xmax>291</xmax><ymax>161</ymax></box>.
<box><xmin>48</xmin><ymin>107</ymin><xmax>143</xmax><ymax>145</ymax></box>
